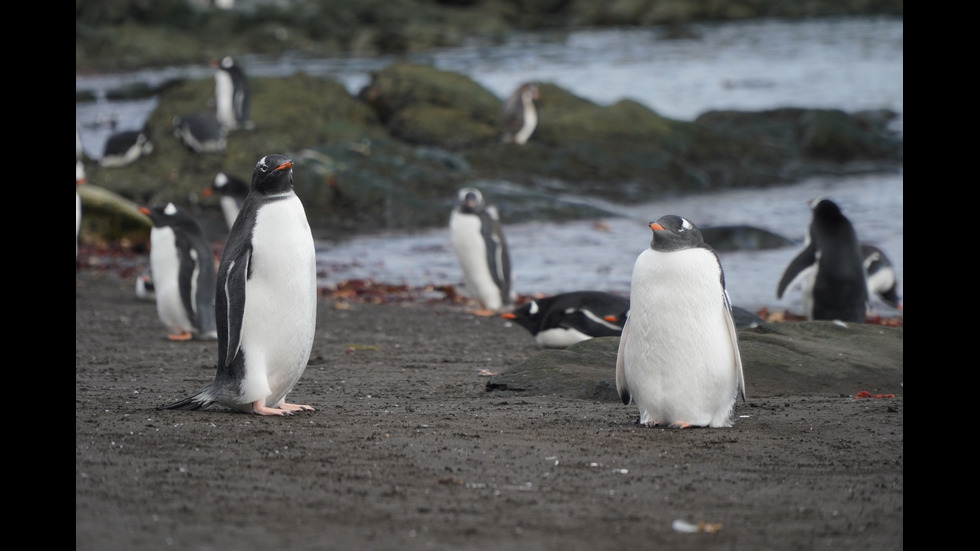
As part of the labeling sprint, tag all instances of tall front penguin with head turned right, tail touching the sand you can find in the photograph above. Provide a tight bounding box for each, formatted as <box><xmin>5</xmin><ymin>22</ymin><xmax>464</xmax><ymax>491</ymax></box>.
<box><xmin>154</xmin><ymin>155</ymin><xmax>317</xmax><ymax>415</ymax></box>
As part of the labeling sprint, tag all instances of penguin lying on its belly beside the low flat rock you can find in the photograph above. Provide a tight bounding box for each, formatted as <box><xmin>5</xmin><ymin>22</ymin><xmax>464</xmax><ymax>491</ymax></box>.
<box><xmin>501</xmin><ymin>291</ymin><xmax>630</xmax><ymax>348</ymax></box>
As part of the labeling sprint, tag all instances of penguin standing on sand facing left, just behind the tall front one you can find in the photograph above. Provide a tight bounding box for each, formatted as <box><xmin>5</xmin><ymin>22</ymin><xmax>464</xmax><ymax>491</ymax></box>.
<box><xmin>140</xmin><ymin>203</ymin><xmax>218</xmax><ymax>341</ymax></box>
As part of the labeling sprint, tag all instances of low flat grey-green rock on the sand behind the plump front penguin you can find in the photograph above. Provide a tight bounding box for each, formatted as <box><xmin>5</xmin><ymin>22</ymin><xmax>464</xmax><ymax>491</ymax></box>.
<box><xmin>487</xmin><ymin>321</ymin><xmax>904</xmax><ymax>401</ymax></box>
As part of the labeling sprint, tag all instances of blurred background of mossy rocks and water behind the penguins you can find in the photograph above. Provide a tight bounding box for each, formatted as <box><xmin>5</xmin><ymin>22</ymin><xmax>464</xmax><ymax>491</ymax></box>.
<box><xmin>76</xmin><ymin>0</ymin><xmax>904</xmax><ymax>316</ymax></box>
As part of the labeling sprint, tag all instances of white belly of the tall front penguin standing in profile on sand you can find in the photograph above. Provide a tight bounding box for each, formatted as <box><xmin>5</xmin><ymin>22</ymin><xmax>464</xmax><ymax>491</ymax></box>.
<box><xmin>242</xmin><ymin>195</ymin><xmax>317</xmax><ymax>407</ymax></box>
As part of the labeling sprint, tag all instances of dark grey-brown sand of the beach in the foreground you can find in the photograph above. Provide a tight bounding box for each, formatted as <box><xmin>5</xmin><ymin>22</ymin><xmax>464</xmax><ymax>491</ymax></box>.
<box><xmin>75</xmin><ymin>267</ymin><xmax>904</xmax><ymax>551</ymax></box>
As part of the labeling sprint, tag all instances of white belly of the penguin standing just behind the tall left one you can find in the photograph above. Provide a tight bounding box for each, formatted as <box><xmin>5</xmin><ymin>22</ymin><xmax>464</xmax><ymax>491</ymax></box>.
<box><xmin>150</xmin><ymin>228</ymin><xmax>194</xmax><ymax>333</ymax></box>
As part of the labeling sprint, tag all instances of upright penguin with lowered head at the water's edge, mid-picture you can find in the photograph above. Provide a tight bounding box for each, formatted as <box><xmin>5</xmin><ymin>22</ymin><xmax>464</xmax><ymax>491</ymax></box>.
<box><xmin>449</xmin><ymin>187</ymin><xmax>517</xmax><ymax>316</ymax></box>
